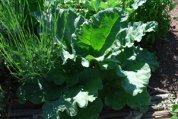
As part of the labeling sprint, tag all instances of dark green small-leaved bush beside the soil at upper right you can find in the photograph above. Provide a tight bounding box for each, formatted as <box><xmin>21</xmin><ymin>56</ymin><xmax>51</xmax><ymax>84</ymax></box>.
<box><xmin>131</xmin><ymin>0</ymin><xmax>175</xmax><ymax>47</ymax></box>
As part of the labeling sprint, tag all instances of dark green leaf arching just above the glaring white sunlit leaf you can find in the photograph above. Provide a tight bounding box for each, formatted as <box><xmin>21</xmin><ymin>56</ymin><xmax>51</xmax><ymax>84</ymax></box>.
<box><xmin>111</xmin><ymin>47</ymin><xmax>159</xmax><ymax>71</ymax></box>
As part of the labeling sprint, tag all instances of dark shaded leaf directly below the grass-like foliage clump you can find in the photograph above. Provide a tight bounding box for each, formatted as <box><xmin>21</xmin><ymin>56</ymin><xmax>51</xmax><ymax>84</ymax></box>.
<box><xmin>17</xmin><ymin>79</ymin><xmax>61</xmax><ymax>104</ymax></box>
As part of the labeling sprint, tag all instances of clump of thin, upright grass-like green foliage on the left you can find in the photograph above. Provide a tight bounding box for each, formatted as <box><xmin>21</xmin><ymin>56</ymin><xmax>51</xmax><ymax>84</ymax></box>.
<box><xmin>0</xmin><ymin>1</ymin><xmax>60</xmax><ymax>80</ymax></box>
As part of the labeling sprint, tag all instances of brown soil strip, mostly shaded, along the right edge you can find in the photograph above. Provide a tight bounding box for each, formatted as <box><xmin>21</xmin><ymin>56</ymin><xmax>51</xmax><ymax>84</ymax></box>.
<box><xmin>150</xmin><ymin>0</ymin><xmax>178</xmax><ymax>94</ymax></box>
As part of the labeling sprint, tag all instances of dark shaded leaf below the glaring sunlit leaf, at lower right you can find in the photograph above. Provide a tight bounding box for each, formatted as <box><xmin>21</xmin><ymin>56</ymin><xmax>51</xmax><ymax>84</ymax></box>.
<box><xmin>105</xmin><ymin>90</ymin><xmax>150</xmax><ymax>112</ymax></box>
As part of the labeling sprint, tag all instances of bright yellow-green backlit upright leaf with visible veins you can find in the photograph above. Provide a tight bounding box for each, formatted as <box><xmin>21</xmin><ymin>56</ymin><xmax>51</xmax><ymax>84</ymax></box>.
<box><xmin>75</xmin><ymin>8</ymin><xmax>126</xmax><ymax>51</ymax></box>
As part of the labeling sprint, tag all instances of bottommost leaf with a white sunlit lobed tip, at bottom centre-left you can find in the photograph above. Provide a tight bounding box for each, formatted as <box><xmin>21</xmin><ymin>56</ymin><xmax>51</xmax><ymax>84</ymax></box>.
<box><xmin>43</xmin><ymin>90</ymin><xmax>96</xmax><ymax>119</ymax></box>
